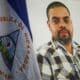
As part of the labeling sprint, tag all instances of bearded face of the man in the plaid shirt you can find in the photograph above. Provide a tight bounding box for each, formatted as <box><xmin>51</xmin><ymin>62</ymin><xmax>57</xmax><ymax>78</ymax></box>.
<box><xmin>47</xmin><ymin>7</ymin><xmax>73</xmax><ymax>44</ymax></box>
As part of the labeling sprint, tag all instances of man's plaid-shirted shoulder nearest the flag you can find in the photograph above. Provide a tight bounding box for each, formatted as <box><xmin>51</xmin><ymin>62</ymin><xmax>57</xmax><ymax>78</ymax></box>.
<box><xmin>37</xmin><ymin>42</ymin><xmax>54</xmax><ymax>68</ymax></box>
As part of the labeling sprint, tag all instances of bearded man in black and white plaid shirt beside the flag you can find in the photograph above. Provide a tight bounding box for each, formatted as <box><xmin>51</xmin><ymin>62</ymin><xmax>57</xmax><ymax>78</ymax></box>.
<box><xmin>37</xmin><ymin>2</ymin><xmax>80</xmax><ymax>80</ymax></box>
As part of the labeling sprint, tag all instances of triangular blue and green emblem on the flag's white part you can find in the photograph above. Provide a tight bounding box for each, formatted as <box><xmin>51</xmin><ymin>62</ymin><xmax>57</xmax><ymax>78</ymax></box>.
<box><xmin>0</xmin><ymin>30</ymin><xmax>19</xmax><ymax>70</ymax></box>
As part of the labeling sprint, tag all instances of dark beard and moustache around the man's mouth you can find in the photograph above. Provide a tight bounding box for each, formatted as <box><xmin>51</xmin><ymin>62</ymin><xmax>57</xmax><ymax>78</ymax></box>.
<box><xmin>54</xmin><ymin>29</ymin><xmax>72</xmax><ymax>45</ymax></box>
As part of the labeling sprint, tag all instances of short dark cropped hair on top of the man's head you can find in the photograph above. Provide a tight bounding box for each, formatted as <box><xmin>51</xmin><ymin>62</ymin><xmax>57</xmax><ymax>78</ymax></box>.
<box><xmin>46</xmin><ymin>1</ymin><xmax>70</xmax><ymax>17</ymax></box>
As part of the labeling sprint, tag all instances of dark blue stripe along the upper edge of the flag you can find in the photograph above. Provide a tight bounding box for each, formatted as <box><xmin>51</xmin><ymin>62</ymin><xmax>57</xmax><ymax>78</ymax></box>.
<box><xmin>7</xmin><ymin>0</ymin><xmax>32</xmax><ymax>39</ymax></box>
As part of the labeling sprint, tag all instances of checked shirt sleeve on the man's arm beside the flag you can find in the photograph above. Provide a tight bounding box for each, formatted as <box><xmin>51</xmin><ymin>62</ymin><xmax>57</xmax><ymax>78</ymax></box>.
<box><xmin>37</xmin><ymin>54</ymin><xmax>54</xmax><ymax>80</ymax></box>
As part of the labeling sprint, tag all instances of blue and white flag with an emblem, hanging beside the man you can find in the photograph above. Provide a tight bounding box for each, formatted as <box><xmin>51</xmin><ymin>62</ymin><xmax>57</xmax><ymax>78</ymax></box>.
<box><xmin>0</xmin><ymin>0</ymin><xmax>40</xmax><ymax>80</ymax></box>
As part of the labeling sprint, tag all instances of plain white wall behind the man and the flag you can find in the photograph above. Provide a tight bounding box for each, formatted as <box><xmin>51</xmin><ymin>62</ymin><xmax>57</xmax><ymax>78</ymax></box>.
<box><xmin>26</xmin><ymin>0</ymin><xmax>80</xmax><ymax>50</ymax></box>
